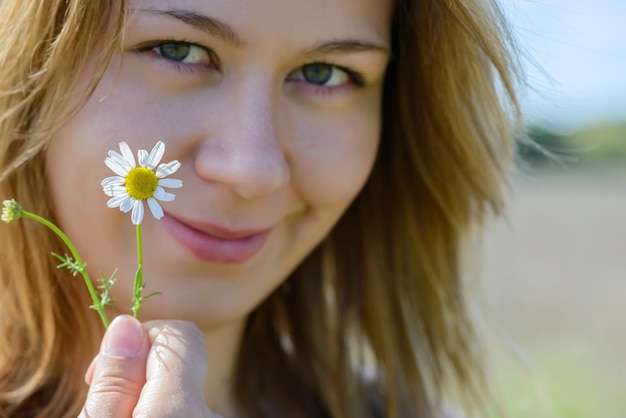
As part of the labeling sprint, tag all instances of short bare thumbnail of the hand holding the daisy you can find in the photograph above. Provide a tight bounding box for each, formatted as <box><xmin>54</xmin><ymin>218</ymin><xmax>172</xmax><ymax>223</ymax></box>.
<box><xmin>103</xmin><ymin>315</ymin><xmax>144</xmax><ymax>358</ymax></box>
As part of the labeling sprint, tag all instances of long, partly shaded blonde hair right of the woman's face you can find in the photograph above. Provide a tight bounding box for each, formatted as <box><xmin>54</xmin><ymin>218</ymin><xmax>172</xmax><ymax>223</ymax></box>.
<box><xmin>233</xmin><ymin>0</ymin><xmax>521</xmax><ymax>418</ymax></box>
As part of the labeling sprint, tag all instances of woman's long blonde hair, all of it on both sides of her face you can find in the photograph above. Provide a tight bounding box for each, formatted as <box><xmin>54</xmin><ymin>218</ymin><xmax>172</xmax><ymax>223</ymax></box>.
<box><xmin>0</xmin><ymin>0</ymin><xmax>519</xmax><ymax>418</ymax></box>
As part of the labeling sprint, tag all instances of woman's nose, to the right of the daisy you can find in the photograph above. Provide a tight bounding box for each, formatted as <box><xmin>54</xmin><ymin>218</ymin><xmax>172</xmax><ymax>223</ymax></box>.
<box><xmin>195</xmin><ymin>83</ymin><xmax>290</xmax><ymax>199</ymax></box>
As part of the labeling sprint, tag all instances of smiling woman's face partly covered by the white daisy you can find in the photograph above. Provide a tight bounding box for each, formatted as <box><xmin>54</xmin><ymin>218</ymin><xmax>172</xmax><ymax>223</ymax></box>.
<box><xmin>47</xmin><ymin>0</ymin><xmax>391</xmax><ymax>325</ymax></box>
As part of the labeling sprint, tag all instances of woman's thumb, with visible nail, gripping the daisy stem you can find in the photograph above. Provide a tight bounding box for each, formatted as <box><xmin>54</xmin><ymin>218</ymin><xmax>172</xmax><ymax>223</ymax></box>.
<box><xmin>79</xmin><ymin>315</ymin><xmax>149</xmax><ymax>418</ymax></box>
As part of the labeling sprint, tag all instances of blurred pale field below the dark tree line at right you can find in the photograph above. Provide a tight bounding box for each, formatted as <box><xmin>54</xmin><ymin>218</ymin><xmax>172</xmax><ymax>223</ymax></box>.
<box><xmin>481</xmin><ymin>171</ymin><xmax>626</xmax><ymax>418</ymax></box>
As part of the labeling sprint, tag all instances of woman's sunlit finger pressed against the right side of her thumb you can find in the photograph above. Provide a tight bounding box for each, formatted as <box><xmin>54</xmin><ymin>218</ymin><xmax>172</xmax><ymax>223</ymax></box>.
<box><xmin>135</xmin><ymin>321</ymin><xmax>217</xmax><ymax>417</ymax></box>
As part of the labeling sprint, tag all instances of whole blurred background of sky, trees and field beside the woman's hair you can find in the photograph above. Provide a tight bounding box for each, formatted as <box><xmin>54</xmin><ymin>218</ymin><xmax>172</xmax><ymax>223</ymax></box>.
<box><xmin>480</xmin><ymin>0</ymin><xmax>626</xmax><ymax>418</ymax></box>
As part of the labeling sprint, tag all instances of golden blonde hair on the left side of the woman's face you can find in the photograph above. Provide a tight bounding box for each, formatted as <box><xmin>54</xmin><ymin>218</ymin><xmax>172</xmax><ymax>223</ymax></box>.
<box><xmin>0</xmin><ymin>0</ymin><xmax>125</xmax><ymax>417</ymax></box>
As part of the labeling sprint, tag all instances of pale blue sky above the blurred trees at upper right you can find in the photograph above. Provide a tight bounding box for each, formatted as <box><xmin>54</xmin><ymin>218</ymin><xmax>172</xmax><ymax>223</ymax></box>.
<box><xmin>502</xmin><ymin>0</ymin><xmax>626</xmax><ymax>129</ymax></box>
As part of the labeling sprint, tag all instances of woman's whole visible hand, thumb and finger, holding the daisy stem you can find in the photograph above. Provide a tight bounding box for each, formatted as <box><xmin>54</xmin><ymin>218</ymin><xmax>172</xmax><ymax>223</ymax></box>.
<box><xmin>79</xmin><ymin>315</ymin><xmax>219</xmax><ymax>418</ymax></box>
